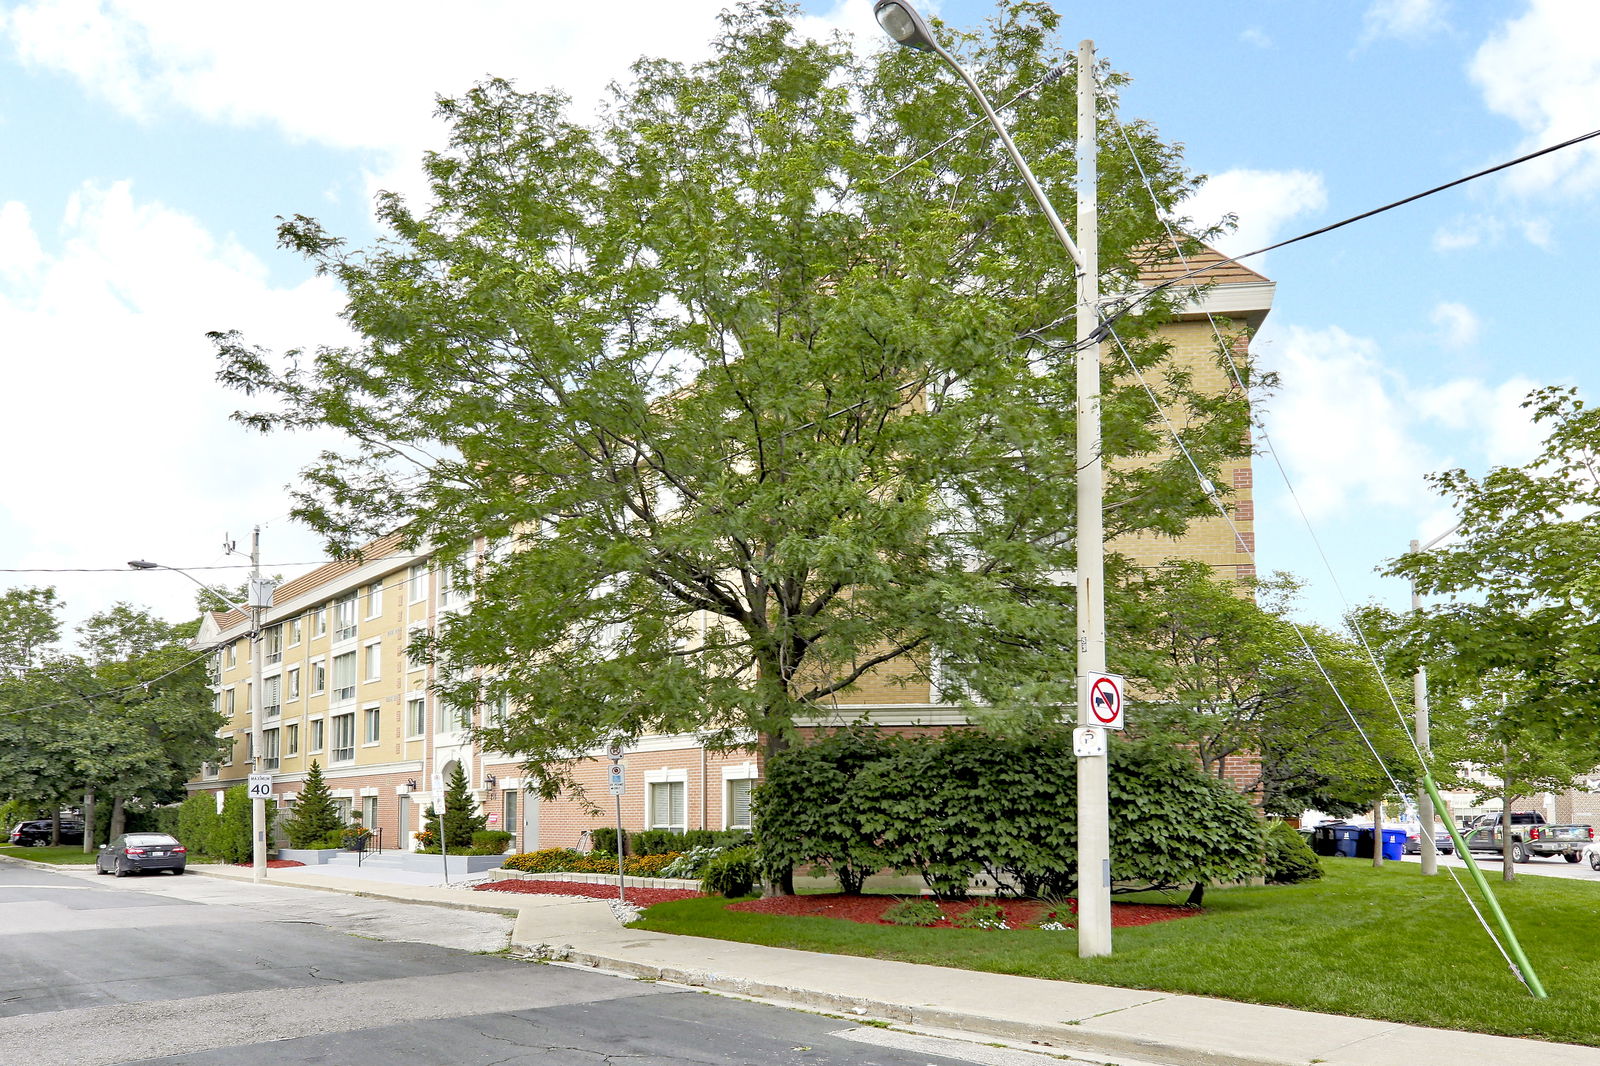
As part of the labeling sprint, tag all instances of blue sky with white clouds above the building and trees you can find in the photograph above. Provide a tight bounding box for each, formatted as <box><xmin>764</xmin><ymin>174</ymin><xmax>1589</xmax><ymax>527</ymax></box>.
<box><xmin>0</xmin><ymin>0</ymin><xmax>1600</xmax><ymax>640</ymax></box>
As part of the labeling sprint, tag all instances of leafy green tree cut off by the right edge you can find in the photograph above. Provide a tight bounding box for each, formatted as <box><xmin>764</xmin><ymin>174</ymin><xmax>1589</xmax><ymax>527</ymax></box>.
<box><xmin>1390</xmin><ymin>387</ymin><xmax>1600</xmax><ymax>767</ymax></box>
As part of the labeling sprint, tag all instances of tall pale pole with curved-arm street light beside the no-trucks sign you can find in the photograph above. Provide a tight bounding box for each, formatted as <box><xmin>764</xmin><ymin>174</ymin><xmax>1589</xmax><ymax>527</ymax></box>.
<box><xmin>872</xmin><ymin>0</ymin><xmax>1110</xmax><ymax>959</ymax></box>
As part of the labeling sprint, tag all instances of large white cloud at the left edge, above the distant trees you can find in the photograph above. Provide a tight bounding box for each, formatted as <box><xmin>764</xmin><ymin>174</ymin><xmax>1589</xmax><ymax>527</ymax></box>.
<box><xmin>0</xmin><ymin>182</ymin><xmax>347</xmax><ymax>616</ymax></box>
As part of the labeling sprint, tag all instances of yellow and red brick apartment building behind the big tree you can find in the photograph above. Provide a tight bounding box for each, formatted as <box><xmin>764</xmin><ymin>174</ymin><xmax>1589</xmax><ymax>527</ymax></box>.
<box><xmin>189</xmin><ymin>250</ymin><xmax>1274</xmax><ymax>850</ymax></box>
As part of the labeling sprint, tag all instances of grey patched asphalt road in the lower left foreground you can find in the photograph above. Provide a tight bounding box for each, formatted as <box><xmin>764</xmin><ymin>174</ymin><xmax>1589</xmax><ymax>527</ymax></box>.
<box><xmin>0</xmin><ymin>863</ymin><xmax>1100</xmax><ymax>1066</ymax></box>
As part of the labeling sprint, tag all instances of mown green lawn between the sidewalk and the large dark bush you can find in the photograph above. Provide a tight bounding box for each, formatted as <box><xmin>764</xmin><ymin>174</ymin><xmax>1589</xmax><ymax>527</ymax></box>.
<box><xmin>635</xmin><ymin>858</ymin><xmax>1600</xmax><ymax>1045</ymax></box>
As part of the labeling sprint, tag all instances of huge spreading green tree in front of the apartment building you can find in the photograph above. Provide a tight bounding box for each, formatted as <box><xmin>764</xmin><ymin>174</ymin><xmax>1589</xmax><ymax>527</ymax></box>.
<box><xmin>214</xmin><ymin>0</ymin><xmax>1248</xmax><ymax>791</ymax></box>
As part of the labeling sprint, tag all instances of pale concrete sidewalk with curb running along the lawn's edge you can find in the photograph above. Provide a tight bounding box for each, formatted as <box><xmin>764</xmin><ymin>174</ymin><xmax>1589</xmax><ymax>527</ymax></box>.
<box><xmin>189</xmin><ymin>866</ymin><xmax>1600</xmax><ymax>1066</ymax></box>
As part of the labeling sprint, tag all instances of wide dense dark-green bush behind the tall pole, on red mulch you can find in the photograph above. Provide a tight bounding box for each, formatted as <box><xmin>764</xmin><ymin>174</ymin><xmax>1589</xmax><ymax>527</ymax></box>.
<box><xmin>755</xmin><ymin>728</ymin><xmax>1261</xmax><ymax>898</ymax></box>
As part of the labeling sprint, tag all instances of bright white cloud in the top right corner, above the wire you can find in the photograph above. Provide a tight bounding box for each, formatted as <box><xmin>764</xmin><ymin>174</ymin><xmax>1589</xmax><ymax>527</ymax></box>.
<box><xmin>1469</xmin><ymin>0</ymin><xmax>1600</xmax><ymax>192</ymax></box>
